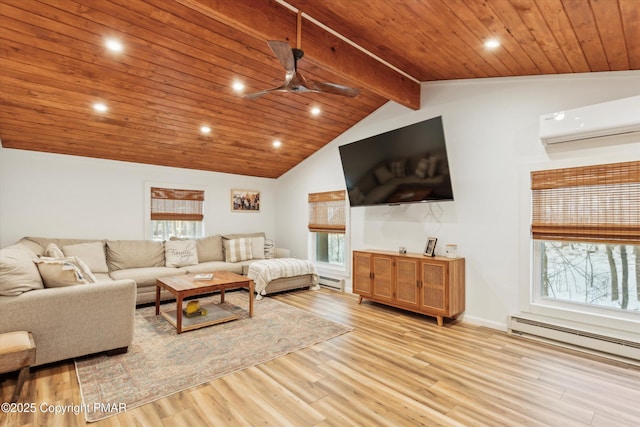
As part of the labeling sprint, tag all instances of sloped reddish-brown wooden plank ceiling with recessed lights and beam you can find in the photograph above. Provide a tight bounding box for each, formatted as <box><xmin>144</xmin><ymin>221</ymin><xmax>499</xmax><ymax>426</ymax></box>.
<box><xmin>0</xmin><ymin>0</ymin><xmax>640</xmax><ymax>178</ymax></box>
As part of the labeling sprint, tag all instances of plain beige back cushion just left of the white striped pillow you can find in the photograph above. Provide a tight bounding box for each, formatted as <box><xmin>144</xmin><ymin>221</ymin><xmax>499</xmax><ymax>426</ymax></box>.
<box><xmin>107</xmin><ymin>240</ymin><xmax>164</xmax><ymax>270</ymax></box>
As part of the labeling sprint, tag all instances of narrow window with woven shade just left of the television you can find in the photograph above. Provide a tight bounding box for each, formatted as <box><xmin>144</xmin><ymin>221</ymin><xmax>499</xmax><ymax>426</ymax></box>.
<box><xmin>309</xmin><ymin>191</ymin><xmax>346</xmax><ymax>267</ymax></box>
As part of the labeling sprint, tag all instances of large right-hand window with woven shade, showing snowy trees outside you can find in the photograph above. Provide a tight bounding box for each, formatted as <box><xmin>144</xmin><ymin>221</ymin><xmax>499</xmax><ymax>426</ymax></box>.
<box><xmin>531</xmin><ymin>162</ymin><xmax>640</xmax><ymax>314</ymax></box>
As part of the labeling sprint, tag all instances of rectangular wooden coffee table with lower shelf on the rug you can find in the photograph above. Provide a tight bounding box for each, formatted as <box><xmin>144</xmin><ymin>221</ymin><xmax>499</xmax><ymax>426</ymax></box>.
<box><xmin>156</xmin><ymin>271</ymin><xmax>254</xmax><ymax>334</ymax></box>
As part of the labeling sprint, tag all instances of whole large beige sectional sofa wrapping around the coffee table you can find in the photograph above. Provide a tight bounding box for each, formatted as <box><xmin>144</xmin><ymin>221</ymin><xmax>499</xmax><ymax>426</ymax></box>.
<box><xmin>0</xmin><ymin>233</ymin><xmax>317</xmax><ymax>365</ymax></box>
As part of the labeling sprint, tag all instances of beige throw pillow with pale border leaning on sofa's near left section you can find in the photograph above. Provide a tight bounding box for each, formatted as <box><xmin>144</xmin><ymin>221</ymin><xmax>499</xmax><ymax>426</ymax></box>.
<box><xmin>34</xmin><ymin>257</ymin><xmax>96</xmax><ymax>288</ymax></box>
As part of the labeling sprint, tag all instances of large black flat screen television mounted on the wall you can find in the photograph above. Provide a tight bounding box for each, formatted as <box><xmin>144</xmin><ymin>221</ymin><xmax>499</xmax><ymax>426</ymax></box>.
<box><xmin>338</xmin><ymin>116</ymin><xmax>453</xmax><ymax>207</ymax></box>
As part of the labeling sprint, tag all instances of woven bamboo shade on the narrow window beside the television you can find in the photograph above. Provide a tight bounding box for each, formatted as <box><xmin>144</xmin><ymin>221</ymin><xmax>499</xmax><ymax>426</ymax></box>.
<box><xmin>309</xmin><ymin>190</ymin><xmax>346</xmax><ymax>233</ymax></box>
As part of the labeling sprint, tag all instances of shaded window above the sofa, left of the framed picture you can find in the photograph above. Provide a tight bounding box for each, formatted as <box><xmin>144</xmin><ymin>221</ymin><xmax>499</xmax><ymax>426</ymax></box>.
<box><xmin>150</xmin><ymin>187</ymin><xmax>204</xmax><ymax>241</ymax></box>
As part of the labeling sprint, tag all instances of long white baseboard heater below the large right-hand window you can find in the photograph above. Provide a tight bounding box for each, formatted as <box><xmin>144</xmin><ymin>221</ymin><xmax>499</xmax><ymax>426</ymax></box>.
<box><xmin>508</xmin><ymin>316</ymin><xmax>640</xmax><ymax>361</ymax></box>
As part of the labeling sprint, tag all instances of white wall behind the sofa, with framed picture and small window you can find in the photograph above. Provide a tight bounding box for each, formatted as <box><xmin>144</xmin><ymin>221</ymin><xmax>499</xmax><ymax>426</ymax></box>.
<box><xmin>0</xmin><ymin>148</ymin><xmax>276</xmax><ymax>247</ymax></box>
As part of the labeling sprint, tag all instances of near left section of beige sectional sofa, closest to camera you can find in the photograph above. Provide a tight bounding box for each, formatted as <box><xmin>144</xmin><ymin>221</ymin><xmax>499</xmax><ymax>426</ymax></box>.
<box><xmin>0</xmin><ymin>242</ymin><xmax>136</xmax><ymax>366</ymax></box>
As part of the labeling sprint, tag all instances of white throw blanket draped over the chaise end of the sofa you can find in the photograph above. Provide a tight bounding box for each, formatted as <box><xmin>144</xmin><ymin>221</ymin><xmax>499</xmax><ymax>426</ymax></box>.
<box><xmin>247</xmin><ymin>258</ymin><xmax>318</xmax><ymax>300</ymax></box>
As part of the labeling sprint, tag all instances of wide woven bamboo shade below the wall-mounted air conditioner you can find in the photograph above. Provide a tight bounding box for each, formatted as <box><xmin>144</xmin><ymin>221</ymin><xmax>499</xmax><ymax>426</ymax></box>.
<box><xmin>531</xmin><ymin>161</ymin><xmax>640</xmax><ymax>244</ymax></box>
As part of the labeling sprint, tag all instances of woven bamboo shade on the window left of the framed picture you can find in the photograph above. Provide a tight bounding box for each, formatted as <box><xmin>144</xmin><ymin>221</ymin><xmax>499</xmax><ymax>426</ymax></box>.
<box><xmin>151</xmin><ymin>187</ymin><xmax>204</xmax><ymax>221</ymax></box>
